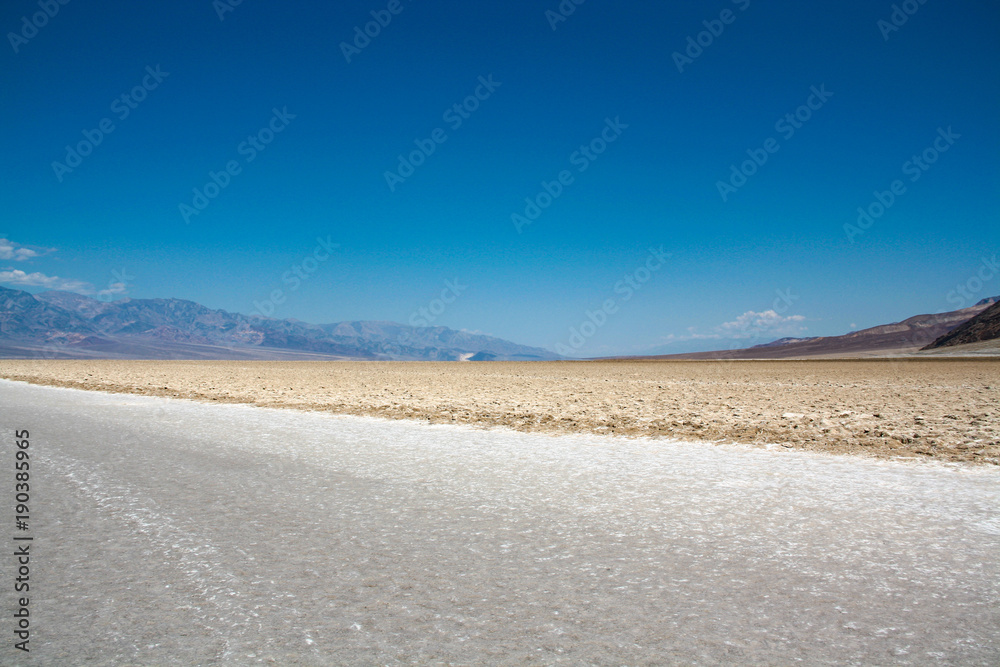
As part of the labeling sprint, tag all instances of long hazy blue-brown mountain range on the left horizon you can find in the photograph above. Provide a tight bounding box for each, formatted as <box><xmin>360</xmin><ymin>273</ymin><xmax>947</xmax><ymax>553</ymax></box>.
<box><xmin>0</xmin><ymin>287</ymin><xmax>559</xmax><ymax>361</ymax></box>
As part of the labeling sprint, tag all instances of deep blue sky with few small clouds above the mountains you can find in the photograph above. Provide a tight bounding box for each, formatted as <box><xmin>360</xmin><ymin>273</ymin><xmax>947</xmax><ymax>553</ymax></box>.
<box><xmin>0</xmin><ymin>0</ymin><xmax>1000</xmax><ymax>356</ymax></box>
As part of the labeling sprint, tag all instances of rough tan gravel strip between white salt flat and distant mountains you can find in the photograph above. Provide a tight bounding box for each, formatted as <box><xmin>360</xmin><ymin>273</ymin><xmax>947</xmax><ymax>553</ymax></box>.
<box><xmin>0</xmin><ymin>359</ymin><xmax>1000</xmax><ymax>465</ymax></box>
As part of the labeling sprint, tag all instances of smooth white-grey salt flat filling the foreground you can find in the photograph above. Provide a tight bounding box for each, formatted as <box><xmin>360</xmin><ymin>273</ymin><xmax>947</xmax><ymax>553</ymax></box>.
<box><xmin>0</xmin><ymin>381</ymin><xmax>1000</xmax><ymax>664</ymax></box>
